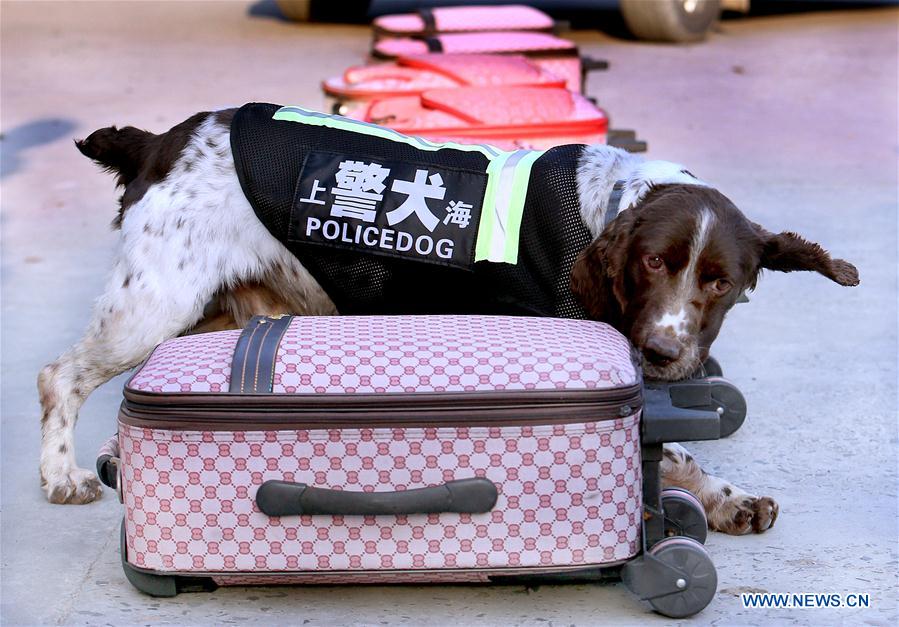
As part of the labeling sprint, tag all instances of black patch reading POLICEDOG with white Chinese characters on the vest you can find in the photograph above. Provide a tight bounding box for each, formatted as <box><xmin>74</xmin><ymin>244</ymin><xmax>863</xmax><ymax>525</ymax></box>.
<box><xmin>288</xmin><ymin>151</ymin><xmax>487</xmax><ymax>269</ymax></box>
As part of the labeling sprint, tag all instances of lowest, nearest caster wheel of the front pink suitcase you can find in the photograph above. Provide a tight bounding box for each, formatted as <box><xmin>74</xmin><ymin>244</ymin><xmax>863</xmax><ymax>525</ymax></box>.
<box><xmin>649</xmin><ymin>537</ymin><xmax>718</xmax><ymax>618</ymax></box>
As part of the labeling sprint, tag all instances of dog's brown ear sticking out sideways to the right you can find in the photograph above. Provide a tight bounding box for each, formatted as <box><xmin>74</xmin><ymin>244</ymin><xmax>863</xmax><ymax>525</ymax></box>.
<box><xmin>754</xmin><ymin>224</ymin><xmax>859</xmax><ymax>286</ymax></box>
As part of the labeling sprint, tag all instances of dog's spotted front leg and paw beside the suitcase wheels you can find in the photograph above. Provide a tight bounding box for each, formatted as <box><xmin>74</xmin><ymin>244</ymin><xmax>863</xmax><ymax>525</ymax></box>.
<box><xmin>662</xmin><ymin>444</ymin><xmax>778</xmax><ymax>536</ymax></box>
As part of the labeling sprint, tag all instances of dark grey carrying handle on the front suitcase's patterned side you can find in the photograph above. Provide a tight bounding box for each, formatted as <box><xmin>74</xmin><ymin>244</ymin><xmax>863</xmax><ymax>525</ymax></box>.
<box><xmin>256</xmin><ymin>477</ymin><xmax>499</xmax><ymax>516</ymax></box>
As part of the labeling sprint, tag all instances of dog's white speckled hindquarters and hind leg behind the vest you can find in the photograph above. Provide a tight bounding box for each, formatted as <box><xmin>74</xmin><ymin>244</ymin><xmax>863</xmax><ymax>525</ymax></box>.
<box><xmin>38</xmin><ymin>110</ymin><xmax>333</xmax><ymax>503</ymax></box>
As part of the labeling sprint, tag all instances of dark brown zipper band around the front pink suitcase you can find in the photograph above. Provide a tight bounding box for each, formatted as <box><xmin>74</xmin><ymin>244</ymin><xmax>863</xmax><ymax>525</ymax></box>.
<box><xmin>119</xmin><ymin>385</ymin><xmax>643</xmax><ymax>430</ymax></box>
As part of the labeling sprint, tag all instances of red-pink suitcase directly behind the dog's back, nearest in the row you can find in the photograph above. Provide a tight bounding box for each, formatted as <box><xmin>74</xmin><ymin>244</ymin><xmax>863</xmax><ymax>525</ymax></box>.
<box><xmin>358</xmin><ymin>87</ymin><xmax>608</xmax><ymax>150</ymax></box>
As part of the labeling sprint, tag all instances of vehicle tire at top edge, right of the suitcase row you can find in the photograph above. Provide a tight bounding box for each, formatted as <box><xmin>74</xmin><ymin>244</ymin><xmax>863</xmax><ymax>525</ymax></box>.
<box><xmin>621</xmin><ymin>0</ymin><xmax>721</xmax><ymax>43</ymax></box>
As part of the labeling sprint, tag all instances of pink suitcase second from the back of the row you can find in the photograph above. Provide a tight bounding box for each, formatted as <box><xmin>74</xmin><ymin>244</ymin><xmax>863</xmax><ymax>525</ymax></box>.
<box><xmin>372</xmin><ymin>32</ymin><xmax>608</xmax><ymax>92</ymax></box>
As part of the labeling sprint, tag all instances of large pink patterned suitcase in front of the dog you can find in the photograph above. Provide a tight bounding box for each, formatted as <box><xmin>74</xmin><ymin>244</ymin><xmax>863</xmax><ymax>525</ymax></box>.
<box><xmin>97</xmin><ymin>316</ymin><xmax>718</xmax><ymax>616</ymax></box>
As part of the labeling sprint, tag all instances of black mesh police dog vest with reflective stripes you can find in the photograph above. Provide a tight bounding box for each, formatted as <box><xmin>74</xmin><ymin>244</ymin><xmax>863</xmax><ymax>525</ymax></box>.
<box><xmin>231</xmin><ymin>103</ymin><xmax>591</xmax><ymax>318</ymax></box>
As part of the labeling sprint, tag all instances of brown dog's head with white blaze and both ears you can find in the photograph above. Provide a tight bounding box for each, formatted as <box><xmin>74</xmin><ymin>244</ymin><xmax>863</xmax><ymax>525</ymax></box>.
<box><xmin>571</xmin><ymin>185</ymin><xmax>858</xmax><ymax>380</ymax></box>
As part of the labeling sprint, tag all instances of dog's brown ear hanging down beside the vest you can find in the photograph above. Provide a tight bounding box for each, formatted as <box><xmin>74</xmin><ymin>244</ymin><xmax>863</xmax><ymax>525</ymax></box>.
<box><xmin>571</xmin><ymin>210</ymin><xmax>635</xmax><ymax>322</ymax></box>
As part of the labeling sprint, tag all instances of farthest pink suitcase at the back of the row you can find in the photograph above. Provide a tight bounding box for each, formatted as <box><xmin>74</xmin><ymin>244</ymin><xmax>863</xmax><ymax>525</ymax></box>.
<box><xmin>372</xmin><ymin>4</ymin><xmax>555</xmax><ymax>37</ymax></box>
